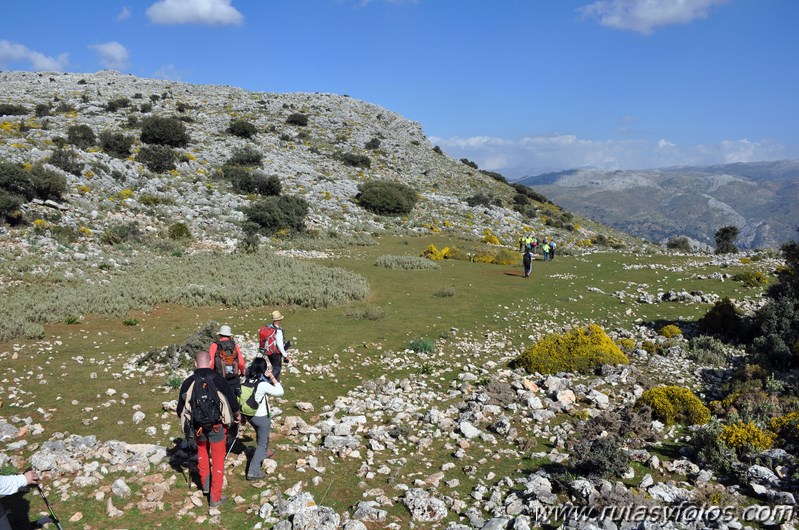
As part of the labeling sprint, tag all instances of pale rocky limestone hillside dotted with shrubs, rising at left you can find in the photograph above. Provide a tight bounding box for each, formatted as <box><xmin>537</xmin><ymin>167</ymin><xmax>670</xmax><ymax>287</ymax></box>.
<box><xmin>0</xmin><ymin>71</ymin><xmax>636</xmax><ymax>268</ymax></box>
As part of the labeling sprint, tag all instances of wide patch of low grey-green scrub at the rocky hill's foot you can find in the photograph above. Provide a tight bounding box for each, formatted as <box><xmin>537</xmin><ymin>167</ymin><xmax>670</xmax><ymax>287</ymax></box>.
<box><xmin>0</xmin><ymin>253</ymin><xmax>369</xmax><ymax>340</ymax></box>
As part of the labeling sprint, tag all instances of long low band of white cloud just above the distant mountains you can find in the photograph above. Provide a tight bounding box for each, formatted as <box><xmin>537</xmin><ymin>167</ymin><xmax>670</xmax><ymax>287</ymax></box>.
<box><xmin>430</xmin><ymin>134</ymin><xmax>799</xmax><ymax>178</ymax></box>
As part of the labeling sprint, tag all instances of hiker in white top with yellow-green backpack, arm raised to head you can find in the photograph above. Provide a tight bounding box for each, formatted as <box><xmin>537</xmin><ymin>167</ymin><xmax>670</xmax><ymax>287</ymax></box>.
<box><xmin>240</xmin><ymin>357</ymin><xmax>283</xmax><ymax>480</ymax></box>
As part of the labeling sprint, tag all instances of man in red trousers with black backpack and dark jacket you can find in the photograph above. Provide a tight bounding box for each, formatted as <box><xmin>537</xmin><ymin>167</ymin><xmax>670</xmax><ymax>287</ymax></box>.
<box><xmin>177</xmin><ymin>351</ymin><xmax>241</xmax><ymax>508</ymax></box>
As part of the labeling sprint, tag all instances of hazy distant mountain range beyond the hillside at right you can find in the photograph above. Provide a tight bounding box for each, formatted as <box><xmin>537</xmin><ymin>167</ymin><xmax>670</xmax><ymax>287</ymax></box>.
<box><xmin>517</xmin><ymin>160</ymin><xmax>799</xmax><ymax>248</ymax></box>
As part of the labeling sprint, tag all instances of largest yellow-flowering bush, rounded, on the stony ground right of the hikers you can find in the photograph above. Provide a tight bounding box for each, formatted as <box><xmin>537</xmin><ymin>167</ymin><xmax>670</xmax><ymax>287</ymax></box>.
<box><xmin>512</xmin><ymin>324</ymin><xmax>630</xmax><ymax>374</ymax></box>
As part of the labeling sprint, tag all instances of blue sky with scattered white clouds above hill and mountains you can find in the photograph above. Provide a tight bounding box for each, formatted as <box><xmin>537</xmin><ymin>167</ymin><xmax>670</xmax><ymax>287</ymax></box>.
<box><xmin>0</xmin><ymin>0</ymin><xmax>799</xmax><ymax>176</ymax></box>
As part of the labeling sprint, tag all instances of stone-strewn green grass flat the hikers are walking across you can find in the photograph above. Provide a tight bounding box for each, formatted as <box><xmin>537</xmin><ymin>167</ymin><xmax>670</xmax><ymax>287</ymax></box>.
<box><xmin>0</xmin><ymin>237</ymin><xmax>768</xmax><ymax>528</ymax></box>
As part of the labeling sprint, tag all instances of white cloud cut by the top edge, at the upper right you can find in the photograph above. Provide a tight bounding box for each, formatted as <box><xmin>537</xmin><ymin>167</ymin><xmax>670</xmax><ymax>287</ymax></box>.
<box><xmin>578</xmin><ymin>0</ymin><xmax>728</xmax><ymax>34</ymax></box>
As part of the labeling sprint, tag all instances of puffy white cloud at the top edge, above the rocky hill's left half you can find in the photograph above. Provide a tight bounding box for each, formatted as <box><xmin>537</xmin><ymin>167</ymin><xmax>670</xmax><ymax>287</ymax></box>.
<box><xmin>146</xmin><ymin>0</ymin><xmax>244</xmax><ymax>26</ymax></box>
